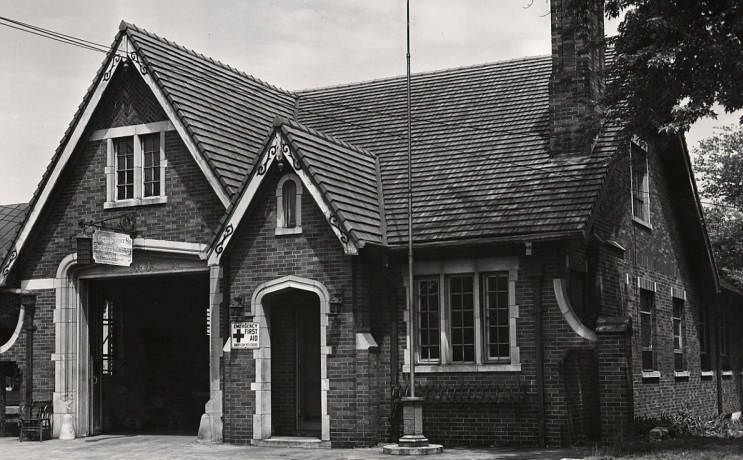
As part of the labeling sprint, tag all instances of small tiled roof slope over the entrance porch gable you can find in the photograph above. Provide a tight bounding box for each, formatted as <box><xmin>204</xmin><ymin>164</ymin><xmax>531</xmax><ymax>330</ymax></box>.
<box><xmin>280</xmin><ymin>121</ymin><xmax>384</xmax><ymax>245</ymax></box>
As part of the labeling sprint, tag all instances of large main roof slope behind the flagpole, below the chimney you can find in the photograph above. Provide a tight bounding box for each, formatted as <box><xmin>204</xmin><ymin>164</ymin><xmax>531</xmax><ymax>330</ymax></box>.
<box><xmin>298</xmin><ymin>56</ymin><xmax>617</xmax><ymax>245</ymax></box>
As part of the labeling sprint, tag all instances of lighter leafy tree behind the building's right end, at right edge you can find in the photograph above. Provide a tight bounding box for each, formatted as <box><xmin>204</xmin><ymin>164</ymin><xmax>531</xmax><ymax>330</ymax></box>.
<box><xmin>694</xmin><ymin>126</ymin><xmax>743</xmax><ymax>286</ymax></box>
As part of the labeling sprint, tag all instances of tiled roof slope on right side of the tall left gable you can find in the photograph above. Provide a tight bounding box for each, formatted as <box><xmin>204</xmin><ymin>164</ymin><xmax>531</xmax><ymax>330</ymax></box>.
<box><xmin>121</xmin><ymin>22</ymin><xmax>295</xmax><ymax>197</ymax></box>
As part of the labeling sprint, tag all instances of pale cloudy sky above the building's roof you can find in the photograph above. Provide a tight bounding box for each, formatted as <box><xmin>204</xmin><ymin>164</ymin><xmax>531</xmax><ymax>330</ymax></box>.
<box><xmin>0</xmin><ymin>0</ymin><xmax>739</xmax><ymax>203</ymax></box>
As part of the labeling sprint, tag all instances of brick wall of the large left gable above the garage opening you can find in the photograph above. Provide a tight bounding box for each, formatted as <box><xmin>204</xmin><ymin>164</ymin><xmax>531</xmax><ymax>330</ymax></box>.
<box><xmin>0</xmin><ymin>66</ymin><xmax>224</xmax><ymax>416</ymax></box>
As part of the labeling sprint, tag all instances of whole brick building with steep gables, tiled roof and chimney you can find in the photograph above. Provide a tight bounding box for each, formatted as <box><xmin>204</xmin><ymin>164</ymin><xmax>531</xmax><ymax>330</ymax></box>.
<box><xmin>0</xmin><ymin>0</ymin><xmax>743</xmax><ymax>446</ymax></box>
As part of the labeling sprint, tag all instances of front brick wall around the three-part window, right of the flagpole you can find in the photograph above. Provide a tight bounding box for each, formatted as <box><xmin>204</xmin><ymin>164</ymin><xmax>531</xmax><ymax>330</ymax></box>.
<box><xmin>386</xmin><ymin>244</ymin><xmax>598</xmax><ymax>446</ymax></box>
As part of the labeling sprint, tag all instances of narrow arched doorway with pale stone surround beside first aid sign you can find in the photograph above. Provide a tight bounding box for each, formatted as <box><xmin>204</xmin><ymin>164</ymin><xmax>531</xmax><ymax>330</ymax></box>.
<box><xmin>251</xmin><ymin>276</ymin><xmax>330</xmax><ymax>441</ymax></box>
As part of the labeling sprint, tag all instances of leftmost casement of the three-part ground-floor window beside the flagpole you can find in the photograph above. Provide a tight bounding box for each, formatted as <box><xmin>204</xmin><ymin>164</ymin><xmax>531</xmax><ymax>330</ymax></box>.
<box><xmin>417</xmin><ymin>278</ymin><xmax>441</xmax><ymax>362</ymax></box>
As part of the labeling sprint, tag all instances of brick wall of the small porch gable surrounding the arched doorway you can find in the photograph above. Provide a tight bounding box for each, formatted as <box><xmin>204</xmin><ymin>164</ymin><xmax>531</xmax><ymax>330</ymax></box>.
<box><xmin>223</xmin><ymin>168</ymin><xmax>383</xmax><ymax>446</ymax></box>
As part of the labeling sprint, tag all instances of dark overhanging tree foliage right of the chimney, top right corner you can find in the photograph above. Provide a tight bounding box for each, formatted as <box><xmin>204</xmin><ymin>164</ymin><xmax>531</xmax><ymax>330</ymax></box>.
<box><xmin>605</xmin><ymin>0</ymin><xmax>743</xmax><ymax>132</ymax></box>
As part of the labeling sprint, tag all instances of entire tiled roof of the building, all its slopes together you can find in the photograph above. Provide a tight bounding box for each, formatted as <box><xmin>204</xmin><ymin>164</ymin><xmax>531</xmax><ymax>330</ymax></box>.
<box><xmin>0</xmin><ymin>22</ymin><xmax>628</xmax><ymax>276</ymax></box>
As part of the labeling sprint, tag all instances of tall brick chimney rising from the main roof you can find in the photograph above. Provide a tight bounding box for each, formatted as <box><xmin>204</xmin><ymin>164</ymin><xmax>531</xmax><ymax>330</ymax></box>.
<box><xmin>550</xmin><ymin>0</ymin><xmax>604</xmax><ymax>156</ymax></box>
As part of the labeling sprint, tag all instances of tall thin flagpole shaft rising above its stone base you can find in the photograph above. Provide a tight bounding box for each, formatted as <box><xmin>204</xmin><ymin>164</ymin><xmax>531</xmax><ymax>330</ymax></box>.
<box><xmin>405</xmin><ymin>0</ymin><xmax>416</xmax><ymax>398</ymax></box>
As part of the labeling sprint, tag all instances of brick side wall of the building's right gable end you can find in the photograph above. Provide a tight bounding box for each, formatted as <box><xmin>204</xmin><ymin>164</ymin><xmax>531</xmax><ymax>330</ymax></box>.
<box><xmin>593</xmin><ymin>136</ymin><xmax>739</xmax><ymax>424</ymax></box>
